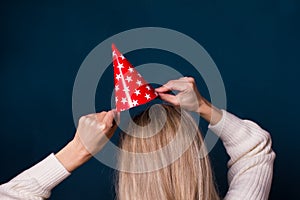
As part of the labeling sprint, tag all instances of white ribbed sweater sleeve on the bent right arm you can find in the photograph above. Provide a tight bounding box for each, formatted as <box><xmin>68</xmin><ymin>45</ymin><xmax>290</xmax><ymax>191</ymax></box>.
<box><xmin>209</xmin><ymin>110</ymin><xmax>275</xmax><ymax>200</ymax></box>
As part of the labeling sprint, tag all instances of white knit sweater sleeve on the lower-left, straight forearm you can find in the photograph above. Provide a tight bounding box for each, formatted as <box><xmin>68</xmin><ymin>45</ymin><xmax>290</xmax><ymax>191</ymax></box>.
<box><xmin>0</xmin><ymin>154</ymin><xmax>70</xmax><ymax>200</ymax></box>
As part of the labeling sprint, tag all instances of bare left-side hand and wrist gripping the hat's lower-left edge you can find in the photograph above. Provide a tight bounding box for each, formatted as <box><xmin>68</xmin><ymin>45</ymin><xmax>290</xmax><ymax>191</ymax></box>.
<box><xmin>56</xmin><ymin>110</ymin><xmax>119</xmax><ymax>172</ymax></box>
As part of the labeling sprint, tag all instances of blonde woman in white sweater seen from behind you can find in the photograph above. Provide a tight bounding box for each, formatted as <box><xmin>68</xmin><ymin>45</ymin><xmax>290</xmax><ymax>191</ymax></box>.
<box><xmin>0</xmin><ymin>77</ymin><xmax>275</xmax><ymax>200</ymax></box>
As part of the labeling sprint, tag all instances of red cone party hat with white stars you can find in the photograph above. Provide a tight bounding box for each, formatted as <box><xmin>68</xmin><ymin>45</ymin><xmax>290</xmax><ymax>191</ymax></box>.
<box><xmin>112</xmin><ymin>44</ymin><xmax>158</xmax><ymax>112</ymax></box>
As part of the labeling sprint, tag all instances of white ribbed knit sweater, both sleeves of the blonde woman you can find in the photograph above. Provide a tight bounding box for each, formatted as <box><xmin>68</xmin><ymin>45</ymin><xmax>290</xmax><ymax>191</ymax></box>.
<box><xmin>0</xmin><ymin>110</ymin><xmax>275</xmax><ymax>200</ymax></box>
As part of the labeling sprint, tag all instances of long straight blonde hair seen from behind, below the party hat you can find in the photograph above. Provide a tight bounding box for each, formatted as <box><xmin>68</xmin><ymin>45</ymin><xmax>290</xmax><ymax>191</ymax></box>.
<box><xmin>116</xmin><ymin>105</ymin><xmax>219</xmax><ymax>200</ymax></box>
